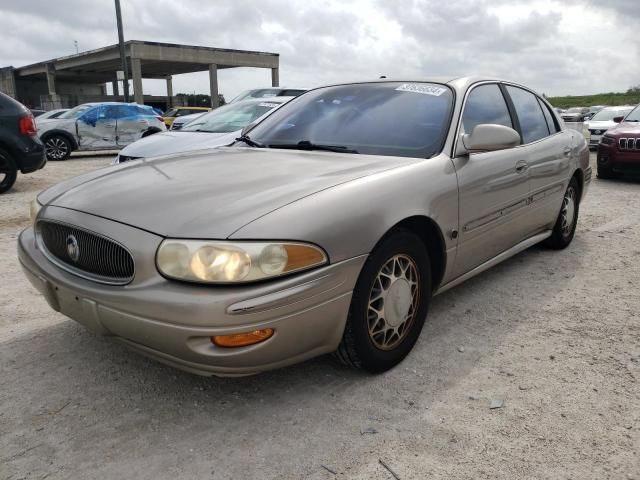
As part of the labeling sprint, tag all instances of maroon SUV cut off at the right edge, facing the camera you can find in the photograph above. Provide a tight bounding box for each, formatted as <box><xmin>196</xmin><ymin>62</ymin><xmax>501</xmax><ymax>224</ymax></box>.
<box><xmin>598</xmin><ymin>105</ymin><xmax>640</xmax><ymax>178</ymax></box>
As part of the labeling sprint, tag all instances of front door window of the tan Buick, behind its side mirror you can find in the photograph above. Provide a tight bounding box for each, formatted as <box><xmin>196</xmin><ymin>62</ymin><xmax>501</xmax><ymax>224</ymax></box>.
<box><xmin>462</xmin><ymin>83</ymin><xmax>513</xmax><ymax>133</ymax></box>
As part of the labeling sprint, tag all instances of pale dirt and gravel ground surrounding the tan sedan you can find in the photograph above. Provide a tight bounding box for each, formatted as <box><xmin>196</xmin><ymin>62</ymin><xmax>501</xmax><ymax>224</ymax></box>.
<box><xmin>0</xmin><ymin>153</ymin><xmax>640</xmax><ymax>480</ymax></box>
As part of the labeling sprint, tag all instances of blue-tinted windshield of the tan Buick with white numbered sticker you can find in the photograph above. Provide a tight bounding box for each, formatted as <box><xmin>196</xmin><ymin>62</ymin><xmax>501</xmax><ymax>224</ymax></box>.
<box><xmin>242</xmin><ymin>82</ymin><xmax>453</xmax><ymax>158</ymax></box>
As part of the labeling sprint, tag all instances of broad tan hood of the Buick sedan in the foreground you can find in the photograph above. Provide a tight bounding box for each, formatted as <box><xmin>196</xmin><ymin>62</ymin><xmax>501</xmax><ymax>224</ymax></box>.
<box><xmin>39</xmin><ymin>147</ymin><xmax>421</xmax><ymax>239</ymax></box>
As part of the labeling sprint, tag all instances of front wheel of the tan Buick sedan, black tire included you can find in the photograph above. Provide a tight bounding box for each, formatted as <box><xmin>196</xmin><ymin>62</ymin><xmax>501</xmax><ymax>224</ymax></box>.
<box><xmin>334</xmin><ymin>230</ymin><xmax>431</xmax><ymax>373</ymax></box>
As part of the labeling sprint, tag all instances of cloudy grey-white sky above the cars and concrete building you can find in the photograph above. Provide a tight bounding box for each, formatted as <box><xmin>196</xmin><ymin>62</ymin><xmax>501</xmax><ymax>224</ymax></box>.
<box><xmin>0</xmin><ymin>0</ymin><xmax>640</xmax><ymax>100</ymax></box>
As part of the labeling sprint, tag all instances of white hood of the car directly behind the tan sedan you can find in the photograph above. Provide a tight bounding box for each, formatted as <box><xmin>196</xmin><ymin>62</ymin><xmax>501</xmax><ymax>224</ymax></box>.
<box><xmin>120</xmin><ymin>130</ymin><xmax>240</xmax><ymax>158</ymax></box>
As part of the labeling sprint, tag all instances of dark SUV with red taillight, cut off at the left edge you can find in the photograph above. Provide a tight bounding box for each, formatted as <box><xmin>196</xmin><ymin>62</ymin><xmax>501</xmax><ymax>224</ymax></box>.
<box><xmin>0</xmin><ymin>92</ymin><xmax>47</xmax><ymax>193</ymax></box>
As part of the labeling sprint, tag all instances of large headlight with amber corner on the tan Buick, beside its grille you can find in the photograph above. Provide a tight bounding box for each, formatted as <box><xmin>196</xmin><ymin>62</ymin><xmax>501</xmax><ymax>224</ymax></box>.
<box><xmin>156</xmin><ymin>240</ymin><xmax>328</xmax><ymax>283</ymax></box>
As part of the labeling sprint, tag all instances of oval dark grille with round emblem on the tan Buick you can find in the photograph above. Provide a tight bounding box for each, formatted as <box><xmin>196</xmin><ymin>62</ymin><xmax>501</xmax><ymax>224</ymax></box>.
<box><xmin>37</xmin><ymin>220</ymin><xmax>134</xmax><ymax>285</ymax></box>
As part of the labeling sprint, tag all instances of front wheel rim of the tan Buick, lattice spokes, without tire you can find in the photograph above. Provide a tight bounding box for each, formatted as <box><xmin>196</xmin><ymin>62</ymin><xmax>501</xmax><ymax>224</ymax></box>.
<box><xmin>367</xmin><ymin>254</ymin><xmax>421</xmax><ymax>350</ymax></box>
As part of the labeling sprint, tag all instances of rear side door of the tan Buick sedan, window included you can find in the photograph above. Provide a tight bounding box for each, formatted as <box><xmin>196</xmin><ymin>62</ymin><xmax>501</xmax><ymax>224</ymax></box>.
<box><xmin>505</xmin><ymin>85</ymin><xmax>572</xmax><ymax>233</ymax></box>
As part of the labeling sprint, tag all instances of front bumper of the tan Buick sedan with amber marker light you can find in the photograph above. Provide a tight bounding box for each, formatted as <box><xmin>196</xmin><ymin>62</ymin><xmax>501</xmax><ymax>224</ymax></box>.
<box><xmin>18</xmin><ymin>212</ymin><xmax>366</xmax><ymax>375</ymax></box>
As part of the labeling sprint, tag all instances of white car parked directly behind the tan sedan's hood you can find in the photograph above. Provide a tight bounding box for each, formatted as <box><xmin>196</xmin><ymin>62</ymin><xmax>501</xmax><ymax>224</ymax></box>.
<box><xmin>113</xmin><ymin>97</ymin><xmax>293</xmax><ymax>164</ymax></box>
